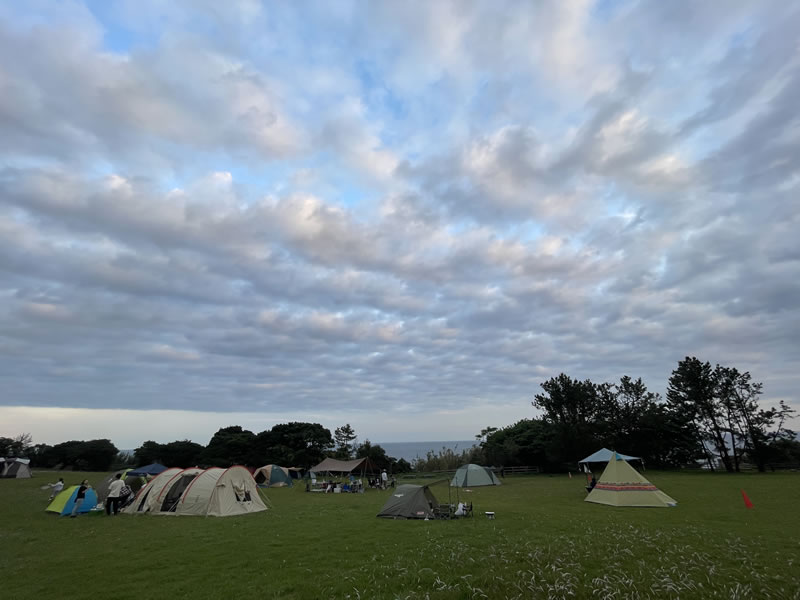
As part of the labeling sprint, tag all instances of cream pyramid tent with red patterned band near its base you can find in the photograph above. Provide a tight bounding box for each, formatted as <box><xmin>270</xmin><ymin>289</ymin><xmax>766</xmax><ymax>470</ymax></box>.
<box><xmin>586</xmin><ymin>453</ymin><xmax>677</xmax><ymax>507</ymax></box>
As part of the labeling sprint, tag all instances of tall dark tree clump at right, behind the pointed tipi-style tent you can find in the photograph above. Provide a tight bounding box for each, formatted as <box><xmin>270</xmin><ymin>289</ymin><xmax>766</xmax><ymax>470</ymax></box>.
<box><xmin>477</xmin><ymin>357</ymin><xmax>800</xmax><ymax>472</ymax></box>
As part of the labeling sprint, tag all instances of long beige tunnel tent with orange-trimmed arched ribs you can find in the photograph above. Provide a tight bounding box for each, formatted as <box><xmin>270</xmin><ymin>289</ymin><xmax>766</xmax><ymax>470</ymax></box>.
<box><xmin>122</xmin><ymin>466</ymin><xmax>267</xmax><ymax>517</ymax></box>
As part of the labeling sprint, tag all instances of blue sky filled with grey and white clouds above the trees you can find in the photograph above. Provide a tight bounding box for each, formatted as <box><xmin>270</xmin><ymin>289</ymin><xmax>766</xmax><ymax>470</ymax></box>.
<box><xmin>0</xmin><ymin>0</ymin><xmax>800</xmax><ymax>448</ymax></box>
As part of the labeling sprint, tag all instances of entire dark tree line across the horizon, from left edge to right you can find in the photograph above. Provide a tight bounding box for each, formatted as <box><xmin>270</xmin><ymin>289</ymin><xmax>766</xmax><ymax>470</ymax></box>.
<box><xmin>0</xmin><ymin>357</ymin><xmax>800</xmax><ymax>473</ymax></box>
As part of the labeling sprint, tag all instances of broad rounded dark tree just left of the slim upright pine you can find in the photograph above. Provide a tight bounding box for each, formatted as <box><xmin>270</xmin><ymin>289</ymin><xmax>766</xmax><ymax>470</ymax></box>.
<box><xmin>255</xmin><ymin>421</ymin><xmax>333</xmax><ymax>469</ymax></box>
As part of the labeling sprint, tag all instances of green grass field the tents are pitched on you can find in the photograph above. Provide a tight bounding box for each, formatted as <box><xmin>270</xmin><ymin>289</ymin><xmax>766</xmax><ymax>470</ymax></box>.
<box><xmin>0</xmin><ymin>472</ymin><xmax>800</xmax><ymax>600</ymax></box>
